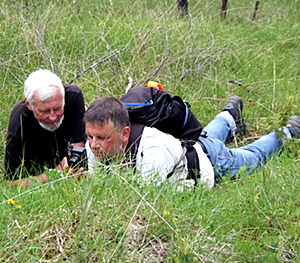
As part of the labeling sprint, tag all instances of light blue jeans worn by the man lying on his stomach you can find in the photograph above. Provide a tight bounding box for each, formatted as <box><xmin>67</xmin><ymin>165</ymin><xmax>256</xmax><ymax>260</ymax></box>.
<box><xmin>199</xmin><ymin>111</ymin><xmax>291</xmax><ymax>182</ymax></box>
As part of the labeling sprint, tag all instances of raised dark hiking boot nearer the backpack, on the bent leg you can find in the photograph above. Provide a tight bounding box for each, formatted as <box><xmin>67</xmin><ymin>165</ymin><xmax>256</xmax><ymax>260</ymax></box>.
<box><xmin>223</xmin><ymin>96</ymin><xmax>246</xmax><ymax>136</ymax></box>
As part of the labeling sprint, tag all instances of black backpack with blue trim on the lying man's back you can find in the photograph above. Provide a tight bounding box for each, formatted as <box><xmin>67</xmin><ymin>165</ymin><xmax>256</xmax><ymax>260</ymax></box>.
<box><xmin>120</xmin><ymin>86</ymin><xmax>202</xmax><ymax>141</ymax></box>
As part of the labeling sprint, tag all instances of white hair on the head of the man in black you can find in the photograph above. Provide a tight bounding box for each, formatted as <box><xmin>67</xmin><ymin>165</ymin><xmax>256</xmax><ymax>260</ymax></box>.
<box><xmin>24</xmin><ymin>69</ymin><xmax>65</xmax><ymax>108</ymax></box>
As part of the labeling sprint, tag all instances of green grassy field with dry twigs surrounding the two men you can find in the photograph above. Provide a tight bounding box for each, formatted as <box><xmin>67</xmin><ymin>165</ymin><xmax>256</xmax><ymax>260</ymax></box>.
<box><xmin>0</xmin><ymin>0</ymin><xmax>300</xmax><ymax>262</ymax></box>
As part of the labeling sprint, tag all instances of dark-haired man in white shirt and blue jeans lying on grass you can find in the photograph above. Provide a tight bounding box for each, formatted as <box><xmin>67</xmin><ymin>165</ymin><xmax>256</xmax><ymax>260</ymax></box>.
<box><xmin>84</xmin><ymin>96</ymin><xmax>300</xmax><ymax>188</ymax></box>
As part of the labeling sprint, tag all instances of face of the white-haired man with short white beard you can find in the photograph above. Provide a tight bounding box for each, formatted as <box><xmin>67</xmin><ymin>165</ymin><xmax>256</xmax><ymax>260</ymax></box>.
<box><xmin>27</xmin><ymin>87</ymin><xmax>64</xmax><ymax>131</ymax></box>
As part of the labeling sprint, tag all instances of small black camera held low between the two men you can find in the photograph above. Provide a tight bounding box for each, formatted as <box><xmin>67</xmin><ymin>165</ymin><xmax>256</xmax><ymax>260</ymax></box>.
<box><xmin>67</xmin><ymin>145</ymin><xmax>87</xmax><ymax>170</ymax></box>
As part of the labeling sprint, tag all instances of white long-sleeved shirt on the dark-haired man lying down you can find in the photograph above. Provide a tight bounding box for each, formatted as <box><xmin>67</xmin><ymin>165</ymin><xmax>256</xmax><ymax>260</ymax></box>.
<box><xmin>86</xmin><ymin>127</ymin><xmax>214</xmax><ymax>189</ymax></box>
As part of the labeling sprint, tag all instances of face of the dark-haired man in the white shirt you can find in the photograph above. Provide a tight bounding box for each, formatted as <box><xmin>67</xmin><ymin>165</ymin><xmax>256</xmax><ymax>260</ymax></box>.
<box><xmin>85</xmin><ymin>121</ymin><xmax>129</xmax><ymax>161</ymax></box>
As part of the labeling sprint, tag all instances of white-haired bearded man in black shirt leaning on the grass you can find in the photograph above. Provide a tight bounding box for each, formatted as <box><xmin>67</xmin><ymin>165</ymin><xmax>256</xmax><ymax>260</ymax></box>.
<box><xmin>5</xmin><ymin>69</ymin><xmax>86</xmax><ymax>186</ymax></box>
